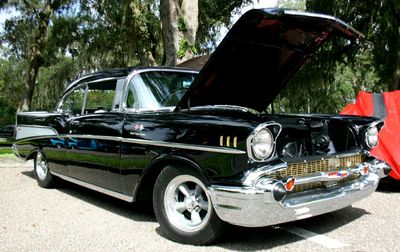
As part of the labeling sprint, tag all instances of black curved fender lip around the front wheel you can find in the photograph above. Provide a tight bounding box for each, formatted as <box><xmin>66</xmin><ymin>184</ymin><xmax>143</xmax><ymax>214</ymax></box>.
<box><xmin>133</xmin><ymin>155</ymin><xmax>207</xmax><ymax>201</ymax></box>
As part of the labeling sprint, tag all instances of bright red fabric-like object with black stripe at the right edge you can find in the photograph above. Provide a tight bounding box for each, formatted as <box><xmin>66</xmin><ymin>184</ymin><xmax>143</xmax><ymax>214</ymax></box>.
<box><xmin>340</xmin><ymin>91</ymin><xmax>400</xmax><ymax>180</ymax></box>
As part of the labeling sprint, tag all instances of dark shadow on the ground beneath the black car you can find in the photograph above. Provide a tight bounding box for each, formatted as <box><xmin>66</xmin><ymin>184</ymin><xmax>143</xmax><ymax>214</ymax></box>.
<box><xmin>22</xmin><ymin>168</ymin><xmax>369</xmax><ymax>251</ymax></box>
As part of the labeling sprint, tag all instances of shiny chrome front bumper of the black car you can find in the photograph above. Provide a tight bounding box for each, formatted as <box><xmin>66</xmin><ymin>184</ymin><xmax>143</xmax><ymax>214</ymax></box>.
<box><xmin>209</xmin><ymin>160</ymin><xmax>390</xmax><ymax>227</ymax></box>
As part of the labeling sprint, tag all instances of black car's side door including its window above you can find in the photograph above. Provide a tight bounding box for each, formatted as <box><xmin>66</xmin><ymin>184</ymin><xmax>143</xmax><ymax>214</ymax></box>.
<box><xmin>62</xmin><ymin>79</ymin><xmax>124</xmax><ymax>192</ymax></box>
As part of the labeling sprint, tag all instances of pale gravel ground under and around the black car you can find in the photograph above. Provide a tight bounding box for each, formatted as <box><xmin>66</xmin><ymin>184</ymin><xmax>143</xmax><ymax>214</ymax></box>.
<box><xmin>0</xmin><ymin>158</ymin><xmax>400</xmax><ymax>252</ymax></box>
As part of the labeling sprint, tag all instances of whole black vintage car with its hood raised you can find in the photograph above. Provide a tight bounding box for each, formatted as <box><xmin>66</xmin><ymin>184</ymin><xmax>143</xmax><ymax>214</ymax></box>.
<box><xmin>14</xmin><ymin>9</ymin><xmax>390</xmax><ymax>244</ymax></box>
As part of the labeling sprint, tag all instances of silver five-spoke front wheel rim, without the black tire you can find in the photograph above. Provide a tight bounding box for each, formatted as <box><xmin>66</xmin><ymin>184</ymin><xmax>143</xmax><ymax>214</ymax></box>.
<box><xmin>164</xmin><ymin>175</ymin><xmax>211</xmax><ymax>232</ymax></box>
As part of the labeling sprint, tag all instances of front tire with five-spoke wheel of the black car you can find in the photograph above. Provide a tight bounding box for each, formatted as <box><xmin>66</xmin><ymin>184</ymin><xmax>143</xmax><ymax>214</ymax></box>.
<box><xmin>153</xmin><ymin>166</ymin><xmax>226</xmax><ymax>245</ymax></box>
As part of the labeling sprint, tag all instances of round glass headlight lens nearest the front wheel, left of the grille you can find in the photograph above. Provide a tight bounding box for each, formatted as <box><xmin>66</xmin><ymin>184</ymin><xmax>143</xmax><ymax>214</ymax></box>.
<box><xmin>251</xmin><ymin>129</ymin><xmax>274</xmax><ymax>160</ymax></box>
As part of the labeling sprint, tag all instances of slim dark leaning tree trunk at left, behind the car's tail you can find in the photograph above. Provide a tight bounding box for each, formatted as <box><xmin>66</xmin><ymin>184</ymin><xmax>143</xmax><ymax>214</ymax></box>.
<box><xmin>18</xmin><ymin>0</ymin><xmax>53</xmax><ymax>111</ymax></box>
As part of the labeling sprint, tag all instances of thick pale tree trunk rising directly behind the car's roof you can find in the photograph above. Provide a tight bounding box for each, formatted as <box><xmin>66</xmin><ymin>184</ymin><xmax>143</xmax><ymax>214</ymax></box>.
<box><xmin>160</xmin><ymin>0</ymin><xmax>199</xmax><ymax>66</ymax></box>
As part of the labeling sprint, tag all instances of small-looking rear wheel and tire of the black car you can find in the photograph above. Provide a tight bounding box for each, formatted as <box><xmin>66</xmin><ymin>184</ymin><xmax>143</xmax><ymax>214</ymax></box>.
<box><xmin>34</xmin><ymin>151</ymin><xmax>54</xmax><ymax>188</ymax></box>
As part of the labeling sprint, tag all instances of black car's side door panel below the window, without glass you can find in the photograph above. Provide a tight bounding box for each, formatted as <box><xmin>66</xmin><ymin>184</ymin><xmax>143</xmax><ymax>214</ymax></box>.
<box><xmin>67</xmin><ymin>113</ymin><xmax>123</xmax><ymax>192</ymax></box>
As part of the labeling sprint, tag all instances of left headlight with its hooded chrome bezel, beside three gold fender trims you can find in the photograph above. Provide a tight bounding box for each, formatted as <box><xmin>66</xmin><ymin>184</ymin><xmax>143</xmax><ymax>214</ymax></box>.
<box><xmin>246</xmin><ymin>122</ymin><xmax>282</xmax><ymax>162</ymax></box>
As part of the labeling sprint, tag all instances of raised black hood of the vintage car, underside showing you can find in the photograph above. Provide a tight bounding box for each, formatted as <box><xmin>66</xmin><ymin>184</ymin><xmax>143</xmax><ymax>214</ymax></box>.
<box><xmin>176</xmin><ymin>9</ymin><xmax>363</xmax><ymax>111</ymax></box>
